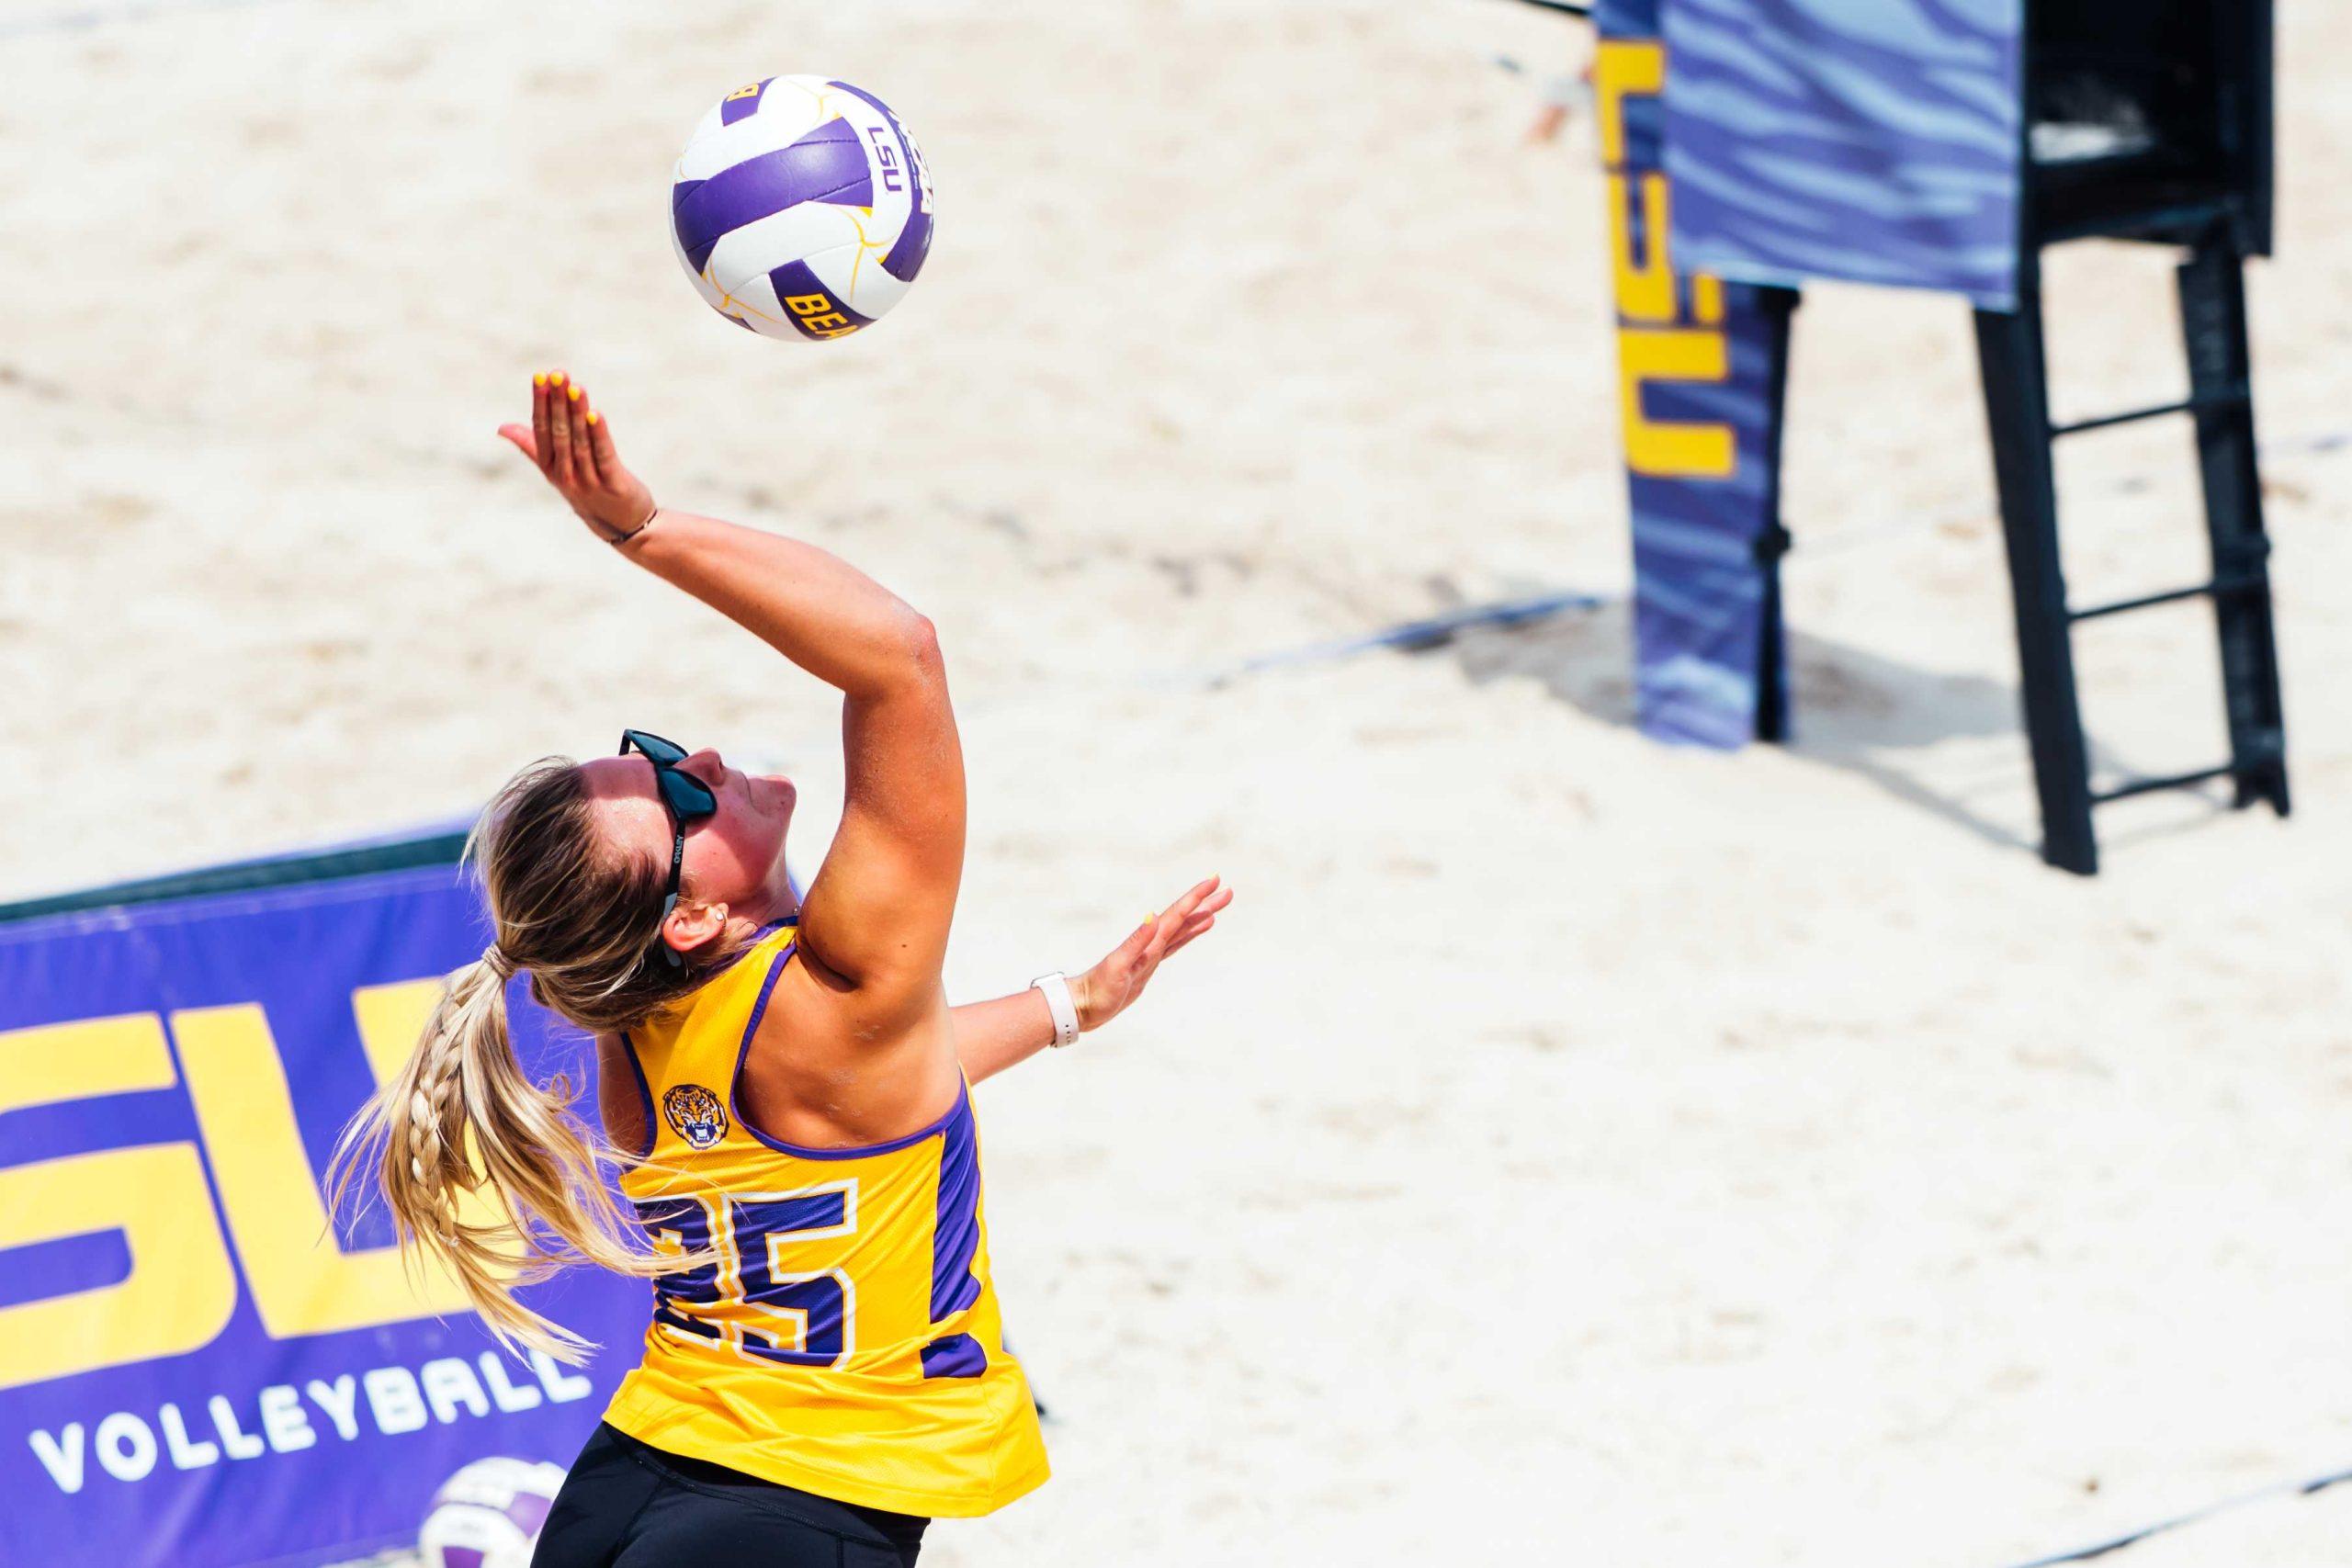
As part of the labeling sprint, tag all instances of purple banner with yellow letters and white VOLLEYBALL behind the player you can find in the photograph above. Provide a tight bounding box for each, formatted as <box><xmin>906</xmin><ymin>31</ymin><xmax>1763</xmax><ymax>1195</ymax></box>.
<box><xmin>0</xmin><ymin>867</ymin><xmax>647</xmax><ymax>1568</ymax></box>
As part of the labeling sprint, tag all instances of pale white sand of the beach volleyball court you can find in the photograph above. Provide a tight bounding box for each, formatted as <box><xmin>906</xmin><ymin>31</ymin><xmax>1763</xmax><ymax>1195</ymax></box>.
<box><xmin>0</xmin><ymin>0</ymin><xmax>2352</xmax><ymax>1568</ymax></box>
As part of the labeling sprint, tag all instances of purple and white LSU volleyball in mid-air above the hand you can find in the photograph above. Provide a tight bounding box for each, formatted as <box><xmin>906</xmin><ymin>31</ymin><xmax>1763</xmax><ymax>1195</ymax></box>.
<box><xmin>671</xmin><ymin>75</ymin><xmax>932</xmax><ymax>341</ymax></box>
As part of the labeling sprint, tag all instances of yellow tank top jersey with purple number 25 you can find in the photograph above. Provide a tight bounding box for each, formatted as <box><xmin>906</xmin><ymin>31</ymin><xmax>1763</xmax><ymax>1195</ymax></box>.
<box><xmin>605</xmin><ymin>926</ymin><xmax>1046</xmax><ymax>1517</ymax></box>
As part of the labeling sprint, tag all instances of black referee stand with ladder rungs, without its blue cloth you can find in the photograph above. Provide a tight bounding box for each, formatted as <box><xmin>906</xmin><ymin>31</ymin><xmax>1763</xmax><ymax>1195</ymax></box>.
<box><xmin>1975</xmin><ymin>0</ymin><xmax>2289</xmax><ymax>874</ymax></box>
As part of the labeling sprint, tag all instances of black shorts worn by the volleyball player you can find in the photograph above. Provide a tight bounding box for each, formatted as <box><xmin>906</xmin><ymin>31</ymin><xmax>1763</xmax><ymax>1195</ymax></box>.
<box><xmin>532</xmin><ymin>1425</ymin><xmax>932</xmax><ymax>1568</ymax></box>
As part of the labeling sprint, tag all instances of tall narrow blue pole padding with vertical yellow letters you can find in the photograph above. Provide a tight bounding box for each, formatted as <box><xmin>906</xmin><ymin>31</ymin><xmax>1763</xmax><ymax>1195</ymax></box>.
<box><xmin>1595</xmin><ymin>0</ymin><xmax>1794</xmax><ymax>748</ymax></box>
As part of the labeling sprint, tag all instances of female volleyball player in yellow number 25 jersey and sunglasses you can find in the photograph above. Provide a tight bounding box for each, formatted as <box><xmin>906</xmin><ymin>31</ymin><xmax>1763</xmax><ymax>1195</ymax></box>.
<box><xmin>360</xmin><ymin>371</ymin><xmax>1230</xmax><ymax>1568</ymax></box>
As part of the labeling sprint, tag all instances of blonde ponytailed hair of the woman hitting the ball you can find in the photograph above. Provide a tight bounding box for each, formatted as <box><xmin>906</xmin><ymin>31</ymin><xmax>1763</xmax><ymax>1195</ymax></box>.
<box><xmin>332</xmin><ymin>757</ymin><xmax>731</xmax><ymax>1361</ymax></box>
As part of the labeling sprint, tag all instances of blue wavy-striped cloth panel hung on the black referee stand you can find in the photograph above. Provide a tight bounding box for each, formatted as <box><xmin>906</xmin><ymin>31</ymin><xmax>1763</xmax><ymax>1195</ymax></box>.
<box><xmin>1665</xmin><ymin>0</ymin><xmax>2025</xmax><ymax>310</ymax></box>
